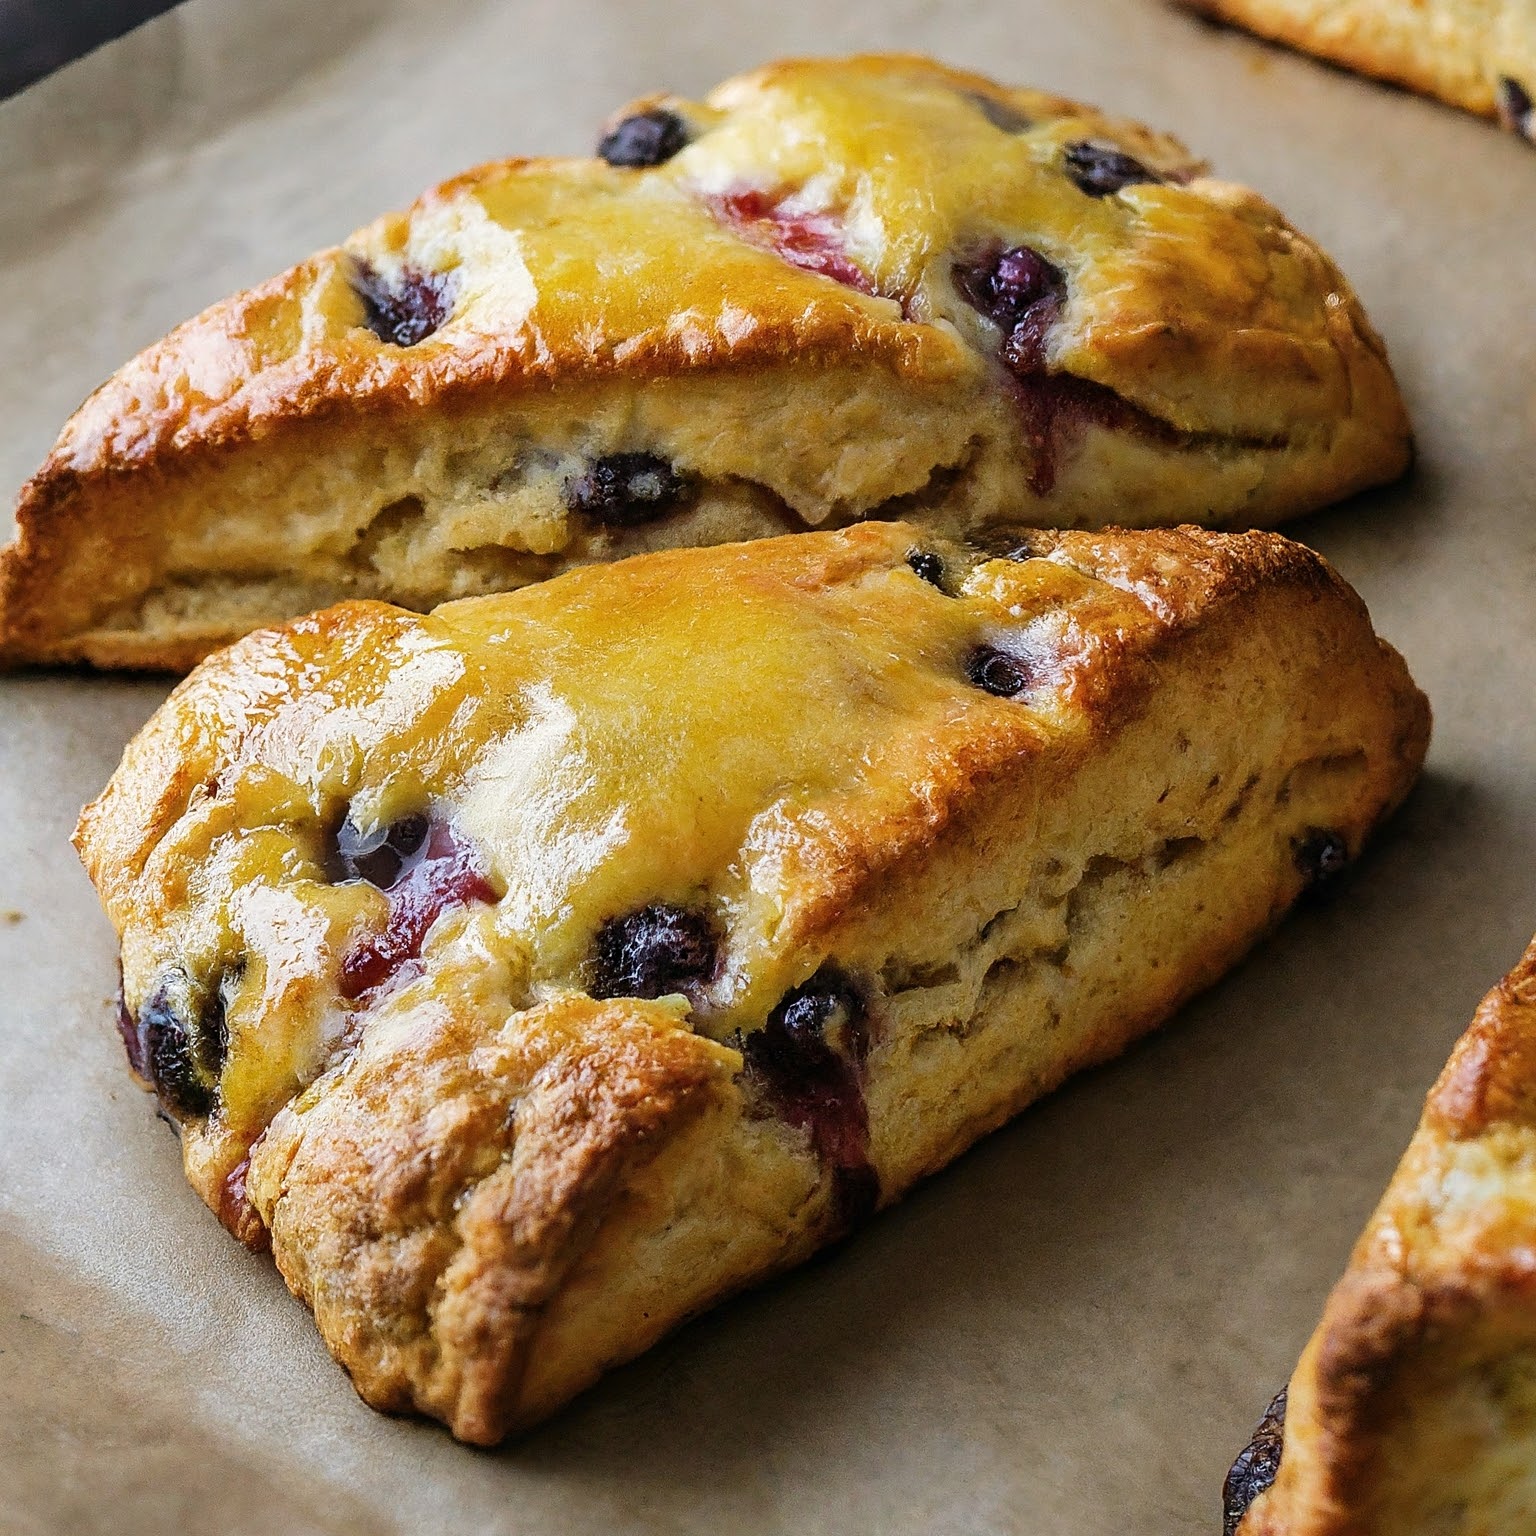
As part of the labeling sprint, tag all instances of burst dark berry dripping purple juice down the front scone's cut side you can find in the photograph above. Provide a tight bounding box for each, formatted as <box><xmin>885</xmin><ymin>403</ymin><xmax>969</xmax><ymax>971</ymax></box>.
<box><xmin>742</xmin><ymin>965</ymin><xmax>880</xmax><ymax>1226</ymax></box>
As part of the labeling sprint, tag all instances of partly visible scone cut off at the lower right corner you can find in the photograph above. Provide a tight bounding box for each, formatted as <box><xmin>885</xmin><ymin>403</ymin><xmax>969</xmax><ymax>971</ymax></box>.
<box><xmin>1226</xmin><ymin>943</ymin><xmax>1536</xmax><ymax>1536</ymax></box>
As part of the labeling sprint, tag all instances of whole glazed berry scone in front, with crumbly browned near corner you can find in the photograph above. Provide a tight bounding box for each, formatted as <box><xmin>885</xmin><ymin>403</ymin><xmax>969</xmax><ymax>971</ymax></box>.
<box><xmin>77</xmin><ymin>522</ymin><xmax>1428</xmax><ymax>1442</ymax></box>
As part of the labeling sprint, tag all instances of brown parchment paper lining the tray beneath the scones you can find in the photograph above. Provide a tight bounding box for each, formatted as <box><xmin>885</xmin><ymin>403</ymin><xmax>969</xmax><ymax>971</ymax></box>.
<box><xmin>0</xmin><ymin>0</ymin><xmax>1536</xmax><ymax>1536</ymax></box>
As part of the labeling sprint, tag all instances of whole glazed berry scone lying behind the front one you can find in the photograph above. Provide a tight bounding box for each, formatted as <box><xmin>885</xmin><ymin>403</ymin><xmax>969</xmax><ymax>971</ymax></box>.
<box><xmin>0</xmin><ymin>57</ymin><xmax>1409</xmax><ymax>668</ymax></box>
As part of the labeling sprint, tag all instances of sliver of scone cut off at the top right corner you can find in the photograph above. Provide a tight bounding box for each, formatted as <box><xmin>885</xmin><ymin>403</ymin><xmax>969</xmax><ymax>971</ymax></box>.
<box><xmin>1181</xmin><ymin>0</ymin><xmax>1536</xmax><ymax>141</ymax></box>
